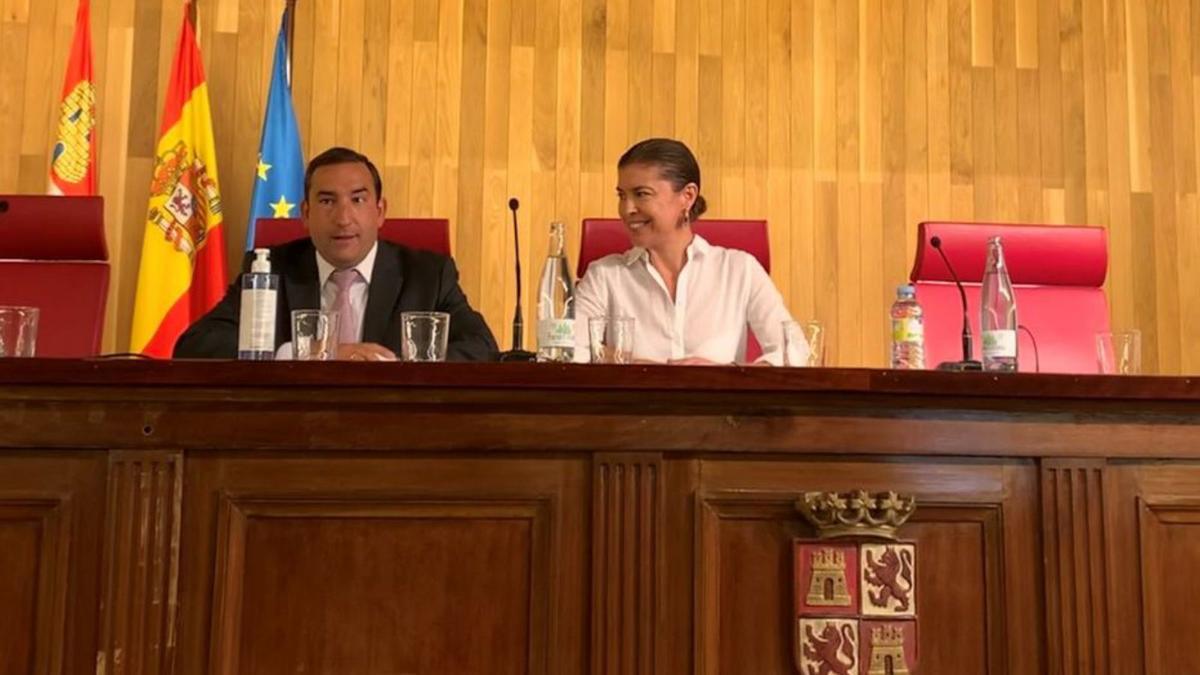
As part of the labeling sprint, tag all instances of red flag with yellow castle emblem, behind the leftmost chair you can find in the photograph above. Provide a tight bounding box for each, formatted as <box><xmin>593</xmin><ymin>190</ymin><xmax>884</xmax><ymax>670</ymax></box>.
<box><xmin>49</xmin><ymin>0</ymin><xmax>96</xmax><ymax>196</ymax></box>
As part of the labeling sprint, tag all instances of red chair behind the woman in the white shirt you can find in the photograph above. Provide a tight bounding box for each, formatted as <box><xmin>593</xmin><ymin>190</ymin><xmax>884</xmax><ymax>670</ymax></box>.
<box><xmin>576</xmin><ymin>217</ymin><xmax>770</xmax><ymax>363</ymax></box>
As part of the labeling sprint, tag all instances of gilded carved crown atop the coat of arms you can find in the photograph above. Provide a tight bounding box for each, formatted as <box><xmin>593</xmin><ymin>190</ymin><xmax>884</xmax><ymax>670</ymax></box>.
<box><xmin>796</xmin><ymin>490</ymin><xmax>917</xmax><ymax>540</ymax></box>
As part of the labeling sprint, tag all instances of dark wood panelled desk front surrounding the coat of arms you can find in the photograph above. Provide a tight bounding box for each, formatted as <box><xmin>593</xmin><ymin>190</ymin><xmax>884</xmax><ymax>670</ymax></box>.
<box><xmin>0</xmin><ymin>359</ymin><xmax>1200</xmax><ymax>675</ymax></box>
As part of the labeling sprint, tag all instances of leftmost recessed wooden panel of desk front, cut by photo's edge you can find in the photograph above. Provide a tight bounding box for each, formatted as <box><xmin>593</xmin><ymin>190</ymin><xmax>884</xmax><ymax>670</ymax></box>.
<box><xmin>0</xmin><ymin>491</ymin><xmax>71</xmax><ymax>675</ymax></box>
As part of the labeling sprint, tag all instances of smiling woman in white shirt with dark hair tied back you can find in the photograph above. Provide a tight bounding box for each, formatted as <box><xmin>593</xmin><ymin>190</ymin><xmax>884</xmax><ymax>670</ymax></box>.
<box><xmin>575</xmin><ymin>138</ymin><xmax>792</xmax><ymax>365</ymax></box>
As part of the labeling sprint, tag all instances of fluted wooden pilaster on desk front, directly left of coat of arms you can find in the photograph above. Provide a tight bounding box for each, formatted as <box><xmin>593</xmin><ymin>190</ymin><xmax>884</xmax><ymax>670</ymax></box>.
<box><xmin>592</xmin><ymin>453</ymin><xmax>664</xmax><ymax>675</ymax></box>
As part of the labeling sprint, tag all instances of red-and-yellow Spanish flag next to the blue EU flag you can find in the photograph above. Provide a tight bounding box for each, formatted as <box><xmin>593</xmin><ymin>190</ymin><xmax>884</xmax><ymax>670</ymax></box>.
<box><xmin>130</xmin><ymin>5</ymin><xmax>226</xmax><ymax>358</ymax></box>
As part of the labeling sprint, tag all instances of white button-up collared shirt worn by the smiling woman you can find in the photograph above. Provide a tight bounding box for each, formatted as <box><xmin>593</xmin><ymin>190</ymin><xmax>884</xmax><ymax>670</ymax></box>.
<box><xmin>575</xmin><ymin>234</ymin><xmax>792</xmax><ymax>365</ymax></box>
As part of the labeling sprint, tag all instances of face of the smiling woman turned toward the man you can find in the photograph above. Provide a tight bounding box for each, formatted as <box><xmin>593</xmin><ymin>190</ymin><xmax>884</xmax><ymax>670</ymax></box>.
<box><xmin>617</xmin><ymin>165</ymin><xmax>698</xmax><ymax>249</ymax></box>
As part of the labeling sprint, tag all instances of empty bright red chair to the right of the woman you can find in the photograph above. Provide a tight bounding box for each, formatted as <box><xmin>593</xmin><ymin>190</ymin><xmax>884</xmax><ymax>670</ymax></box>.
<box><xmin>910</xmin><ymin>222</ymin><xmax>1109</xmax><ymax>372</ymax></box>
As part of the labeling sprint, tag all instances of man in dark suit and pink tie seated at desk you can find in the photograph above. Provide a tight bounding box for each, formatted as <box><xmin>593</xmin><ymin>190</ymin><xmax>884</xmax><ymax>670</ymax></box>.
<box><xmin>174</xmin><ymin>148</ymin><xmax>497</xmax><ymax>360</ymax></box>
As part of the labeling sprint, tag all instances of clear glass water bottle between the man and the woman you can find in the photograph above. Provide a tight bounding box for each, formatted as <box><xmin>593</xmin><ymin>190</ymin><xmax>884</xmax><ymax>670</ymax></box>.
<box><xmin>538</xmin><ymin>222</ymin><xmax>575</xmax><ymax>363</ymax></box>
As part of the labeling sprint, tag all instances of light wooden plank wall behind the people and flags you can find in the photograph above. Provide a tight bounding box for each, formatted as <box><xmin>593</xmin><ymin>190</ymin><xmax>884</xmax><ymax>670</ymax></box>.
<box><xmin>0</xmin><ymin>0</ymin><xmax>1200</xmax><ymax>374</ymax></box>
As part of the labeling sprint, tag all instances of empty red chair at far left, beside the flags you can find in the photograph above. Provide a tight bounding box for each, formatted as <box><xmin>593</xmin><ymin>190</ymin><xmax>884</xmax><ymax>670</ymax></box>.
<box><xmin>0</xmin><ymin>195</ymin><xmax>109</xmax><ymax>358</ymax></box>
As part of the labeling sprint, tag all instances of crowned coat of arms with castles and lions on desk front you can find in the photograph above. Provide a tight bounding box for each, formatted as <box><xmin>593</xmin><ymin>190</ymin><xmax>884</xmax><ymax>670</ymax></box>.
<box><xmin>793</xmin><ymin>490</ymin><xmax>917</xmax><ymax>675</ymax></box>
